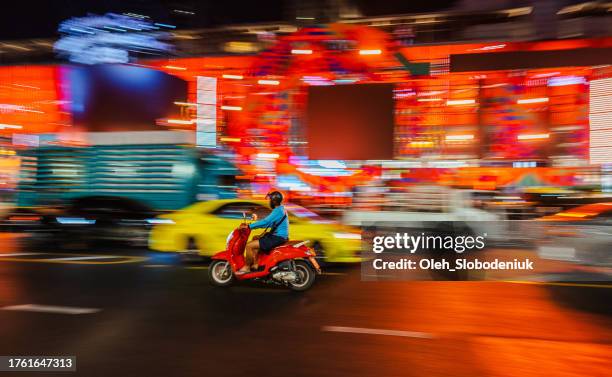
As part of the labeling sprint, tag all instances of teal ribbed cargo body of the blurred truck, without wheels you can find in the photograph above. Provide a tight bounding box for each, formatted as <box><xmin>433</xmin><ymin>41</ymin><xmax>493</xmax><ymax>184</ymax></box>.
<box><xmin>17</xmin><ymin>145</ymin><xmax>238</xmax><ymax>211</ymax></box>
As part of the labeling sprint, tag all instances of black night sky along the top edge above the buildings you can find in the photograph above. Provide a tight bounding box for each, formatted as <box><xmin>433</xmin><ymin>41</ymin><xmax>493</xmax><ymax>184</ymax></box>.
<box><xmin>0</xmin><ymin>0</ymin><xmax>455</xmax><ymax>40</ymax></box>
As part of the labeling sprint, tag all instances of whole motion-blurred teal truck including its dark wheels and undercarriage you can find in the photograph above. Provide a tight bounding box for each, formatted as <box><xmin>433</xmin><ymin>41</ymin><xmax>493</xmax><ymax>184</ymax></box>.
<box><xmin>9</xmin><ymin>133</ymin><xmax>240</xmax><ymax>245</ymax></box>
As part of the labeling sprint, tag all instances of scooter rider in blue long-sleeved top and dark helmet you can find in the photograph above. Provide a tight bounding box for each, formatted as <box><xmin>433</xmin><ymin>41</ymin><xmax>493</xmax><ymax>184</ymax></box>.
<box><xmin>237</xmin><ymin>191</ymin><xmax>289</xmax><ymax>274</ymax></box>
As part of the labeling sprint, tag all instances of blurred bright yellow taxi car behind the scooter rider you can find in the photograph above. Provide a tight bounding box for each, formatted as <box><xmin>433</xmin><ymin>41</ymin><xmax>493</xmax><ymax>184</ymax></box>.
<box><xmin>149</xmin><ymin>199</ymin><xmax>361</xmax><ymax>263</ymax></box>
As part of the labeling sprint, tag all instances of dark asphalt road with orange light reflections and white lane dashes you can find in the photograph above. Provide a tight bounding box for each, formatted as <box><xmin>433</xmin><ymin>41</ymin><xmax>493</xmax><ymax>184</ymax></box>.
<box><xmin>0</xmin><ymin>235</ymin><xmax>612</xmax><ymax>377</ymax></box>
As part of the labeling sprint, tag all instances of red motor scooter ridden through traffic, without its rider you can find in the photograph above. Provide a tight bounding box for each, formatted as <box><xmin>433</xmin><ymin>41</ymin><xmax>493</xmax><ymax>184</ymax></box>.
<box><xmin>208</xmin><ymin>216</ymin><xmax>321</xmax><ymax>291</ymax></box>
